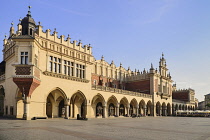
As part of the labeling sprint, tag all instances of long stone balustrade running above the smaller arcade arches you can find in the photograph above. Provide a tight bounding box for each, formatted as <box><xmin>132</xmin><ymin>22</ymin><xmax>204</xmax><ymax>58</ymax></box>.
<box><xmin>92</xmin><ymin>85</ymin><xmax>152</xmax><ymax>98</ymax></box>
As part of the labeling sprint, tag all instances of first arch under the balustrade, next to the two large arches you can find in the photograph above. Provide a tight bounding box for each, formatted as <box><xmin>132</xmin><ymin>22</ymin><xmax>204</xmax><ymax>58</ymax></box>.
<box><xmin>91</xmin><ymin>94</ymin><xmax>105</xmax><ymax>118</ymax></box>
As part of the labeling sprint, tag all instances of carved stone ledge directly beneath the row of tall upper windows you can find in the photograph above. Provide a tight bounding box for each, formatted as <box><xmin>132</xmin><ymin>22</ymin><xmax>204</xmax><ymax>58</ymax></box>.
<box><xmin>43</xmin><ymin>71</ymin><xmax>89</xmax><ymax>83</ymax></box>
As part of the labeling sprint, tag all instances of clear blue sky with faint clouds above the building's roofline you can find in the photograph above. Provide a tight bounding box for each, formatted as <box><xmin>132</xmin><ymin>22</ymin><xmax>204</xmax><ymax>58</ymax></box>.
<box><xmin>0</xmin><ymin>0</ymin><xmax>210</xmax><ymax>101</ymax></box>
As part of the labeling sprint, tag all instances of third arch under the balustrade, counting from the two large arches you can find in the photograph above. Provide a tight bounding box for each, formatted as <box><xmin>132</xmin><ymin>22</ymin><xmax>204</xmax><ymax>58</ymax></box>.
<box><xmin>119</xmin><ymin>97</ymin><xmax>129</xmax><ymax>116</ymax></box>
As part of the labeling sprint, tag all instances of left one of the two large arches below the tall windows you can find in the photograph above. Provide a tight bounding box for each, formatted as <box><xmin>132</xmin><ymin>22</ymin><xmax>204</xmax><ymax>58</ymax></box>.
<box><xmin>46</xmin><ymin>88</ymin><xmax>67</xmax><ymax>118</ymax></box>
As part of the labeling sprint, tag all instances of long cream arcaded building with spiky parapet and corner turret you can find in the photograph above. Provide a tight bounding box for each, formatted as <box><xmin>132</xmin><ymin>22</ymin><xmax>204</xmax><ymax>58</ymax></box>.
<box><xmin>0</xmin><ymin>8</ymin><xmax>196</xmax><ymax>120</ymax></box>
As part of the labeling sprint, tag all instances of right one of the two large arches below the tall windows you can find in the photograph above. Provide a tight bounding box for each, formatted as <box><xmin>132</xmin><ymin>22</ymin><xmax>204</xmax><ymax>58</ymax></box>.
<box><xmin>70</xmin><ymin>91</ymin><xmax>87</xmax><ymax>118</ymax></box>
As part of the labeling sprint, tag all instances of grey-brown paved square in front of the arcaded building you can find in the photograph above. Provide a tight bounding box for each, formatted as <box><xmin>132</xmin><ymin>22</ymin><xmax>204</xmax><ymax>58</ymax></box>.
<box><xmin>0</xmin><ymin>117</ymin><xmax>210</xmax><ymax>140</ymax></box>
